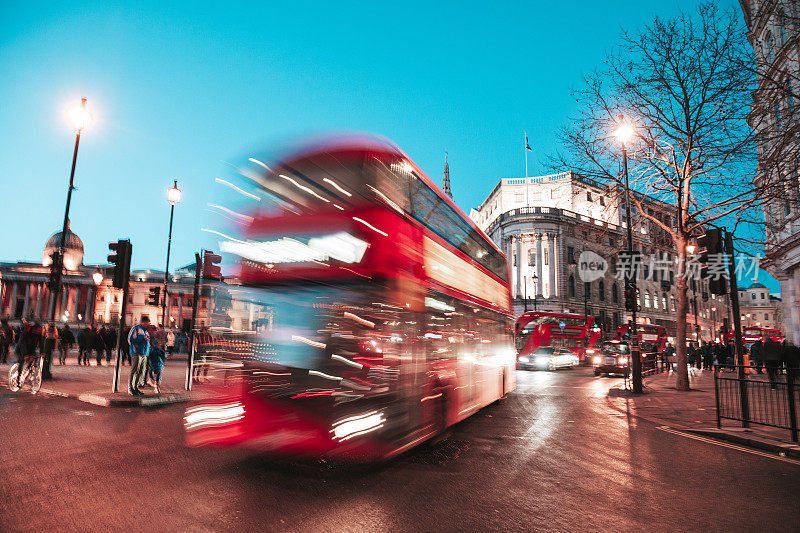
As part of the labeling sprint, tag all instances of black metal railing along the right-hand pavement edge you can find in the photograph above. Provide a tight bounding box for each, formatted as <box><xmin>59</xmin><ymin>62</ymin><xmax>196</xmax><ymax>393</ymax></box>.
<box><xmin>714</xmin><ymin>365</ymin><xmax>800</xmax><ymax>442</ymax></box>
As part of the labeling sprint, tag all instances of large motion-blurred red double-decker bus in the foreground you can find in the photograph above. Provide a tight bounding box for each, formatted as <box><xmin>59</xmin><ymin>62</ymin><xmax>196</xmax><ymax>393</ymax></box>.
<box><xmin>185</xmin><ymin>135</ymin><xmax>515</xmax><ymax>460</ymax></box>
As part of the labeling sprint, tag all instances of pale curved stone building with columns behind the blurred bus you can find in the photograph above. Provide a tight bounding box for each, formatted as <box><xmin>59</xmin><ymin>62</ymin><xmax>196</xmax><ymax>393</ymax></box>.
<box><xmin>470</xmin><ymin>172</ymin><xmax>728</xmax><ymax>340</ymax></box>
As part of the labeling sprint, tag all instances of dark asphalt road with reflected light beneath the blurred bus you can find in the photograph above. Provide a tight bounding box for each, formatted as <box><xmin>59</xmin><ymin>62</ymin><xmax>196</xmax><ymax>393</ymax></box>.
<box><xmin>0</xmin><ymin>369</ymin><xmax>800</xmax><ymax>531</ymax></box>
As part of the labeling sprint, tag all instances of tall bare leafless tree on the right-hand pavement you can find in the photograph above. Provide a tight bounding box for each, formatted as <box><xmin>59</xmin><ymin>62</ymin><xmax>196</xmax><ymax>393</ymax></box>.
<box><xmin>550</xmin><ymin>3</ymin><xmax>775</xmax><ymax>390</ymax></box>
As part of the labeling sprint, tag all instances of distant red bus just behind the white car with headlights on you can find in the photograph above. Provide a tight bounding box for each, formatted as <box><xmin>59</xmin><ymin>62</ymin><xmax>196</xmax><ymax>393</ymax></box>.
<box><xmin>514</xmin><ymin>311</ymin><xmax>600</xmax><ymax>361</ymax></box>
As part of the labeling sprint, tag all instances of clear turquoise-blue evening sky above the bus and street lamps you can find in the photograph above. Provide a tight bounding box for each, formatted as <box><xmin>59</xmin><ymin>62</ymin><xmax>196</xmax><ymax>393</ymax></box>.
<box><xmin>0</xmin><ymin>0</ymin><xmax>776</xmax><ymax>290</ymax></box>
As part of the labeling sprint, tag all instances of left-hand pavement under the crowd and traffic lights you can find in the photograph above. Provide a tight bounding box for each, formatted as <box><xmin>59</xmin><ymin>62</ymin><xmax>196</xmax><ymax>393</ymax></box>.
<box><xmin>0</xmin><ymin>354</ymin><xmax>194</xmax><ymax>407</ymax></box>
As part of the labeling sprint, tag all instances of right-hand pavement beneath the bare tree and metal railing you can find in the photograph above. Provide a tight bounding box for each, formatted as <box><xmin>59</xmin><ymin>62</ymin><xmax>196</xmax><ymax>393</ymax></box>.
<box><xmin>607</xmin><ymin>368</ymin><xmax>800</xmax><ymax>457</ymax></box>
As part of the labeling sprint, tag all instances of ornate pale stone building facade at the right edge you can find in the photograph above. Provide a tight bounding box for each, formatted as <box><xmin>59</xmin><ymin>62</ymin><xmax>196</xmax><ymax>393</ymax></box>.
<box><xmin>740</xmin><ymin>0</ymin><xmax>800</xmax><ymax>345</ymax></box>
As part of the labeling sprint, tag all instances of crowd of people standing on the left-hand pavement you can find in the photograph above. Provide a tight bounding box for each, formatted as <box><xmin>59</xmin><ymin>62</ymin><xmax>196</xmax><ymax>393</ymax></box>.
<box><xmin>0</xmin><ymin>317</ymin><xmax>188</xmax><ymax>394</ymax></box>
